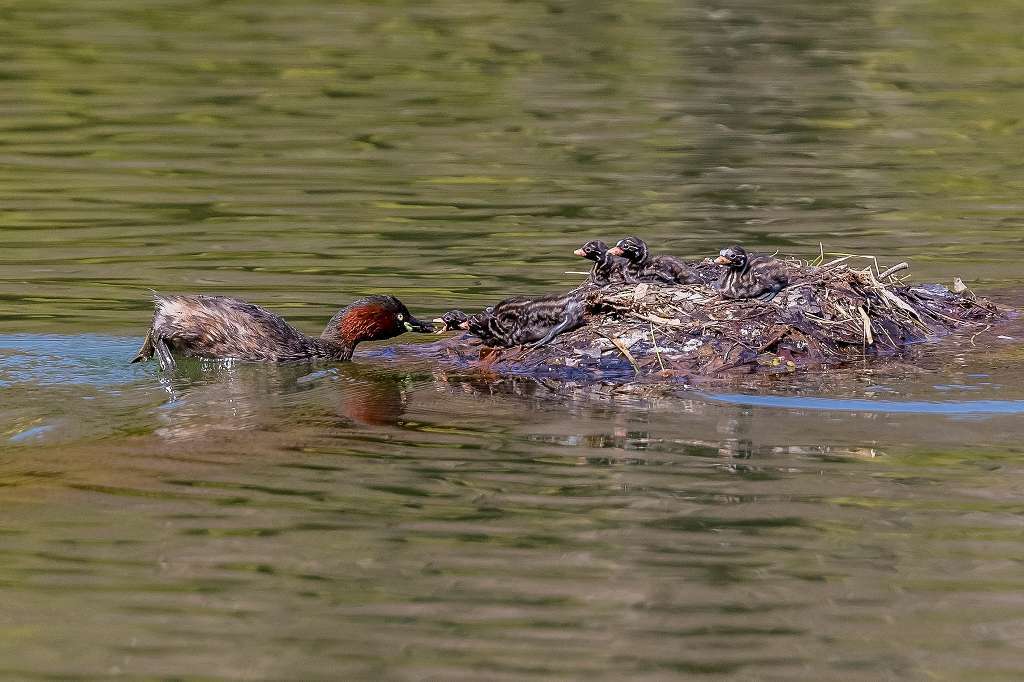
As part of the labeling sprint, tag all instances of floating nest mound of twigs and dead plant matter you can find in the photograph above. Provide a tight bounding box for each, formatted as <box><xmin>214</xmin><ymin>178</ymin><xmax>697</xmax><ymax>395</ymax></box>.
<box><xmin>430</xmin><ymin>251</ymin><xmax>1011</xmax><ymax>383</ymax></box>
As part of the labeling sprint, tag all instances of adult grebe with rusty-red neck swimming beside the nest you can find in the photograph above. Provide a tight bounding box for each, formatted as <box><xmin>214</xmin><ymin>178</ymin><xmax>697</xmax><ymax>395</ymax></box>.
<box><xmin>132</xmin><ymin>294</ymin><xmax>433</xmax><ymax>370</ymax></box>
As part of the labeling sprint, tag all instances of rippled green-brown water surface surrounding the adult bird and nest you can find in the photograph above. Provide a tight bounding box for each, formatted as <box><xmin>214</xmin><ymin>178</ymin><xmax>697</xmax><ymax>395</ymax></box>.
<box><xmin>0</xmin><ymin>0</ymin><xmax>1024</xmax><ymax>680</ymax></box>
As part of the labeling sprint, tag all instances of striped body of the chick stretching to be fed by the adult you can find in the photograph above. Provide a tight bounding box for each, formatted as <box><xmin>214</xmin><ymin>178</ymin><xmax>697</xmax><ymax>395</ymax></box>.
<box><xmin>466</xmin><ymin>294</ymin><xmax>586</xmax><ymax>348</ymax></box>
